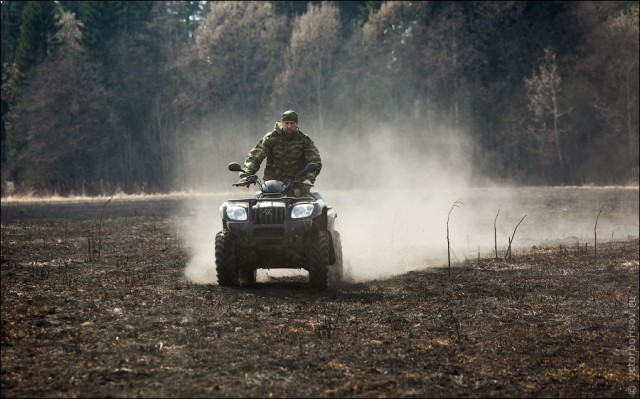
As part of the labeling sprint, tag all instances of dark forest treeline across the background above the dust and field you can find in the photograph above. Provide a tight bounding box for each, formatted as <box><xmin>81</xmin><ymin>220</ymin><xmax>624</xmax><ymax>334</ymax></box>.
<box><xmin>1</xmin><ymin>1</ymin><xmax>640</xmax><ymax>194</ymax></box>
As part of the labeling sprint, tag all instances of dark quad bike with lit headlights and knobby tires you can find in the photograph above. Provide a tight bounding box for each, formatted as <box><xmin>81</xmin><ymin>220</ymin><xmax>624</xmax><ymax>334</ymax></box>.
<box><xmin>215</xmin><ymin>162</ymin><xmax>343</xmax><ymax>290</ymax></box>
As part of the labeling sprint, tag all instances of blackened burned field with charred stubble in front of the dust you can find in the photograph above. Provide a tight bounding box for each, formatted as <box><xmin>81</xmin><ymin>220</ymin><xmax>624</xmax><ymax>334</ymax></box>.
<box><xmin>0</xmin><ymin>201</ymin><xmax>639</xmax><ymax>397</ymax></box>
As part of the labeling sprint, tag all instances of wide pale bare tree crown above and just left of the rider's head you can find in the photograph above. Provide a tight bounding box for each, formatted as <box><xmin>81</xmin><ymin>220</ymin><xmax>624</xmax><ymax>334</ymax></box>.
<box><xmin>187</xmin><ymin>1</ymin><xmax>283</xmax><ymax>127</ymax></box>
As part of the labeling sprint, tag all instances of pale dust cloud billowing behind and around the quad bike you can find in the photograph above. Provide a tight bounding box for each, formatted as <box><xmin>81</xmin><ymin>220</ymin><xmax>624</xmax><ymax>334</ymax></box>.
<box><xmin>180</xmin><ymin>121</ymin><xmax>639</xmax><ymax>284</ymax></box>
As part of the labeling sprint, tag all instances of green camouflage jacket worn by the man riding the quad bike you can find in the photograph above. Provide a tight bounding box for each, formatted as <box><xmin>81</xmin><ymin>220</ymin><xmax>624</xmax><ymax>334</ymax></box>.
<box><xmin>240</xmin><ymin>122</ymin><xmax>322</xmax><ymax>183</ymax></box>
